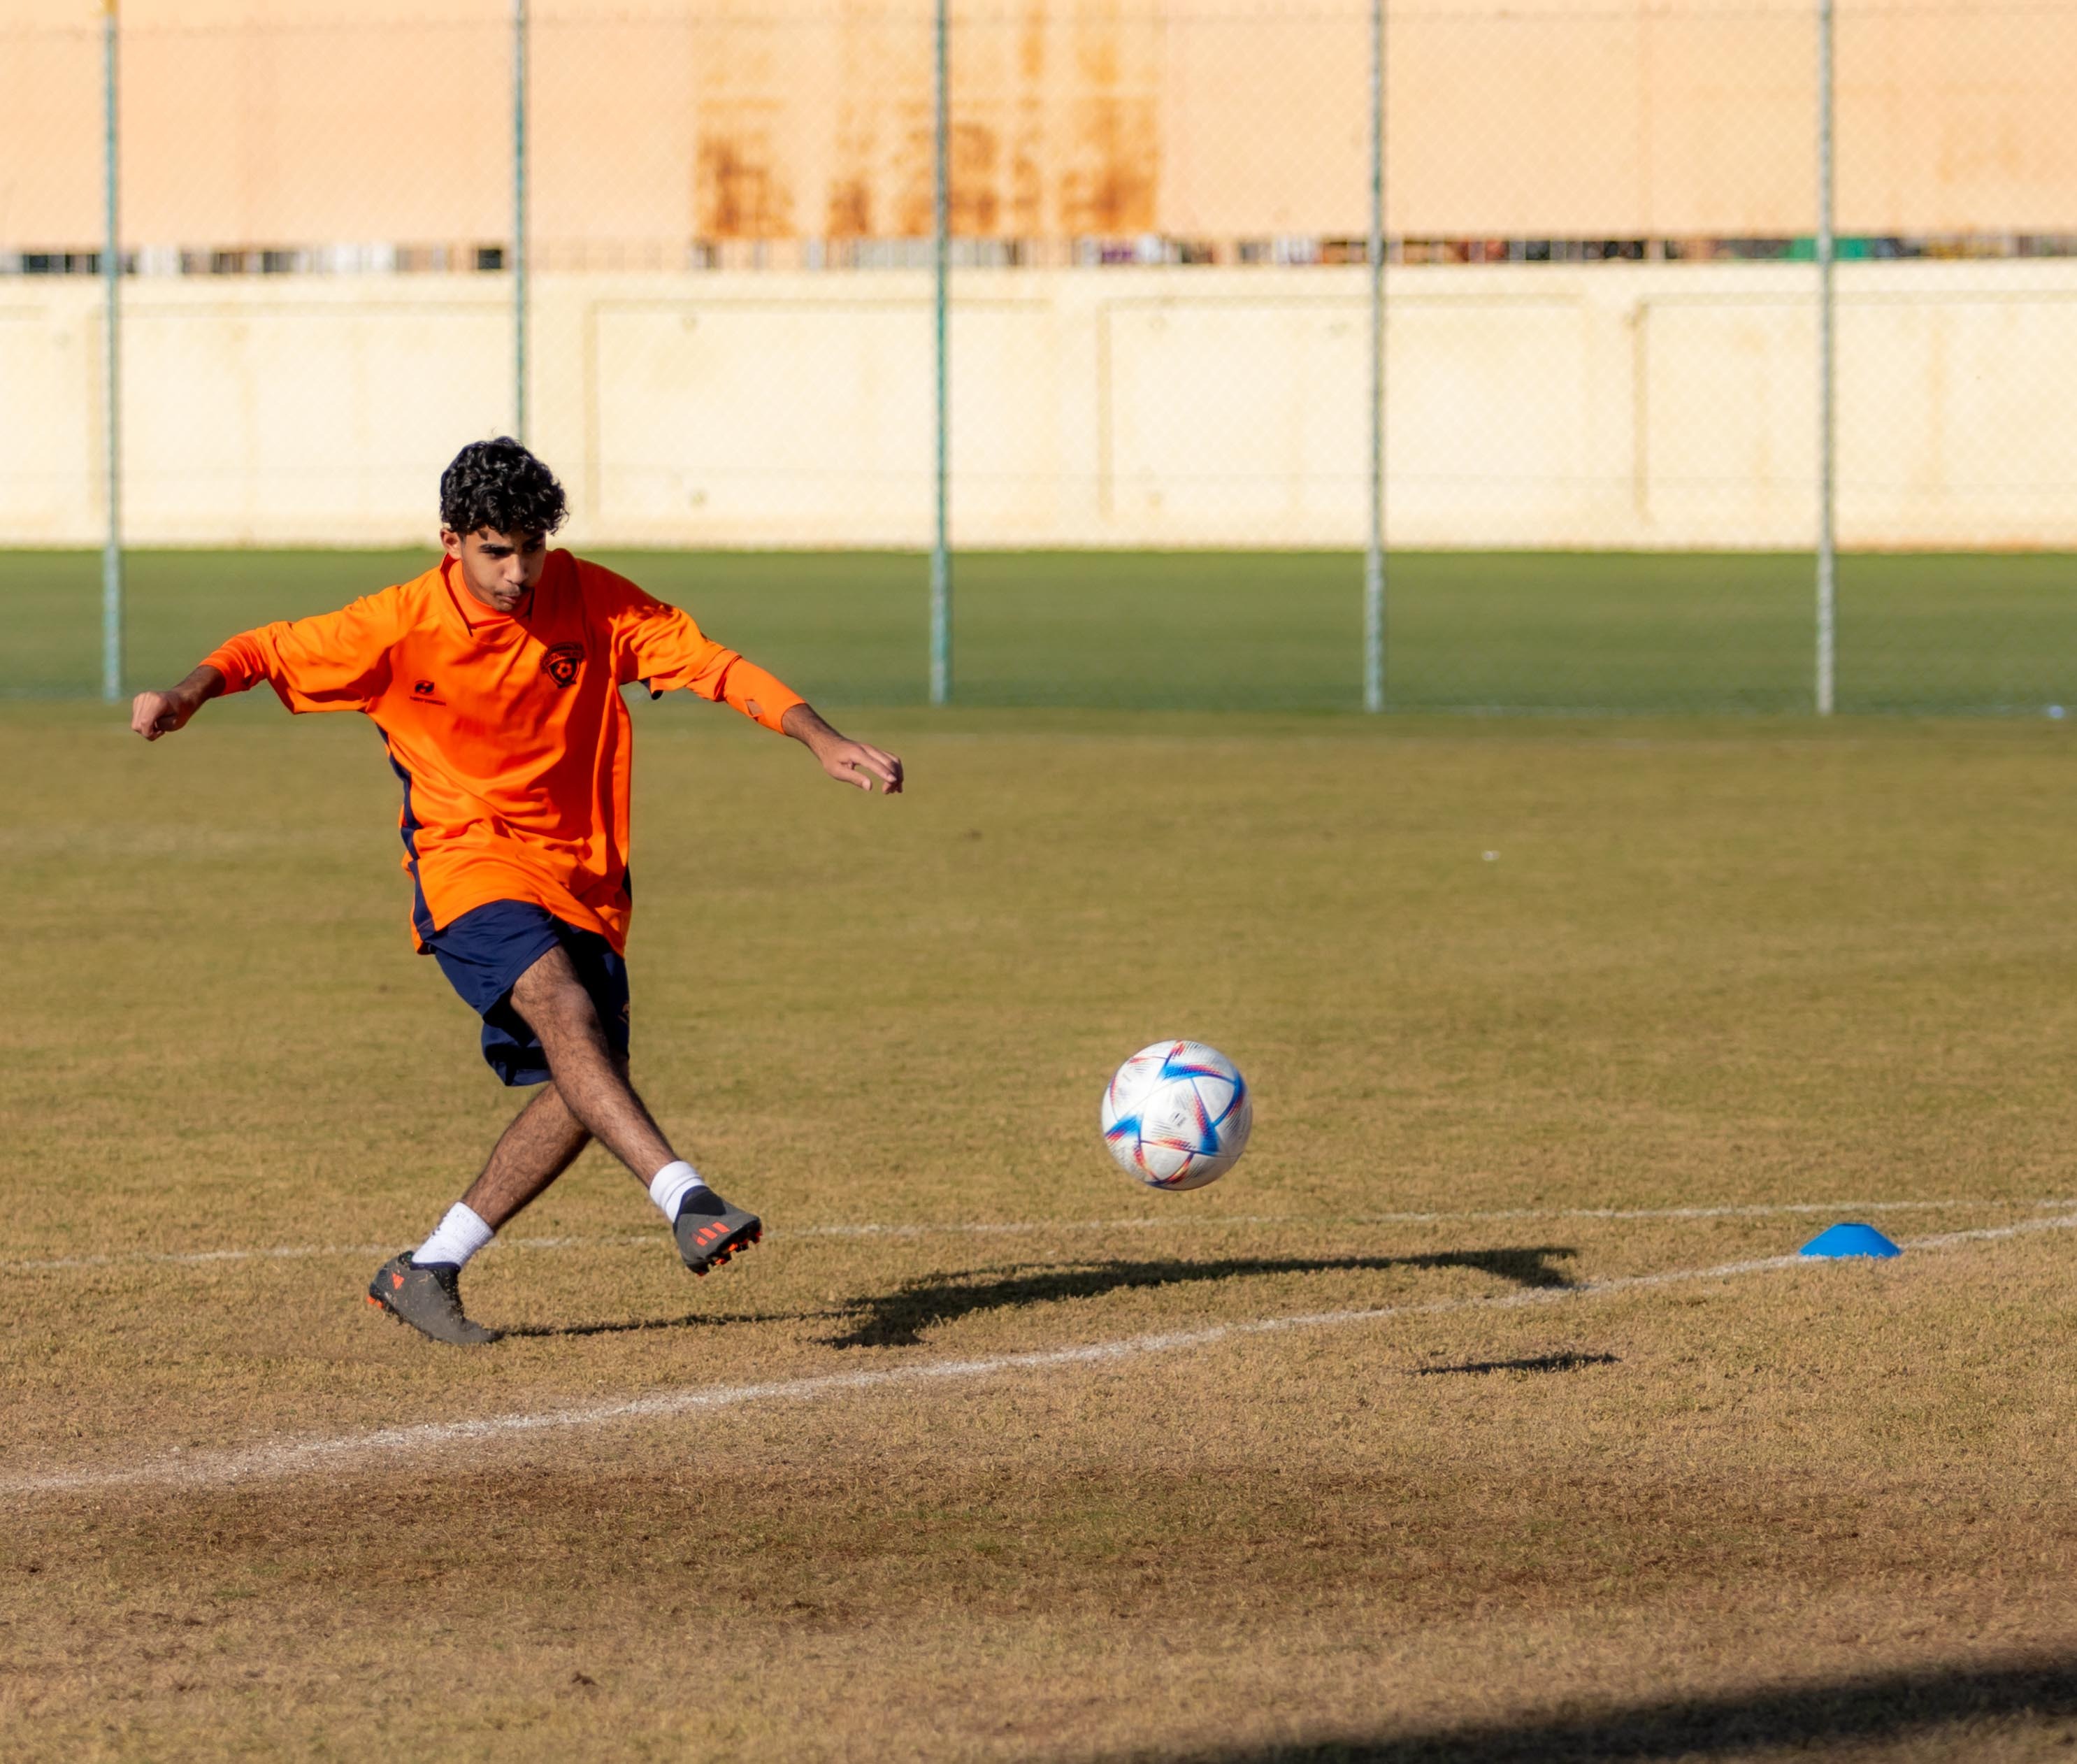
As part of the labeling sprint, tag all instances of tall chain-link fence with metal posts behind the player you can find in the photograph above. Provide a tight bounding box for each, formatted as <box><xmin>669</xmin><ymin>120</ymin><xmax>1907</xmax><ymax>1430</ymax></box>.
<box><xmin>0</xmin><ymin>0</ymin><xmax>2077</xmax><ymax>710</ymax></box>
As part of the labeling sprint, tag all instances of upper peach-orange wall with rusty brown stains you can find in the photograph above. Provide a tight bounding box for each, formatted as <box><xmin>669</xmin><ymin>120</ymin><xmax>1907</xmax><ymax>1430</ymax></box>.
<box><xmin>0</xmin><ymin>0</ymin><xmax>2077</xmax><ymax>247</ymax></box>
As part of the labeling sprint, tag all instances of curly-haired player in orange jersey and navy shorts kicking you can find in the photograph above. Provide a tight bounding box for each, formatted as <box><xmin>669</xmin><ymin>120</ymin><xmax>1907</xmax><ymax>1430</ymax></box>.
<box><xmin>131</xmin><ymin>438</ymin><xmax>901</xmax><ymax>1347</ymax></box>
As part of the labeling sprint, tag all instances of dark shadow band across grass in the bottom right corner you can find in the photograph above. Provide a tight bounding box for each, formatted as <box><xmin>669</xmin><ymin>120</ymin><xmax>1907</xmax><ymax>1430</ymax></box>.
<box><xmin>1126</xmin><ymin>1654</ymin><xmax>2077</xmax><ymax>1764</ymax></box>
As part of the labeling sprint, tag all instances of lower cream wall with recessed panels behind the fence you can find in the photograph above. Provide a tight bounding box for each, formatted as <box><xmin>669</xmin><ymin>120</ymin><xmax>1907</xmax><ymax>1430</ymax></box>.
<box><xmin>12</xmin><ymin>261</ymin><xmax>2077</xmax><ymax>547</ymax></box>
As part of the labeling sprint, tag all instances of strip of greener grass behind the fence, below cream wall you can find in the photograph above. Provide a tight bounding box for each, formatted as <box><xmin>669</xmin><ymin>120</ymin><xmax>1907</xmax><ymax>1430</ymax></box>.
<box><xmin>12</xmin><ymin>551</ymin><xmax>2077</xmax><ymax>712</ymax></box>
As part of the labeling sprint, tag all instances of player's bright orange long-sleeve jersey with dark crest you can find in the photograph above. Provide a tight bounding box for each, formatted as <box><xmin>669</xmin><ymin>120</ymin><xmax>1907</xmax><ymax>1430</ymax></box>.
<box><xmin>206</xmin><ymin>551</ymin><xmax>802</xmax><ymax>952</ymax></box>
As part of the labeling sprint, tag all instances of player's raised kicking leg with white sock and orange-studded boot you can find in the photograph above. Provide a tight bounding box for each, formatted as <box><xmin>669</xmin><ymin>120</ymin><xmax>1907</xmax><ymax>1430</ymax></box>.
<box><xmin>506</xmin><ymin>945</ymin><xmax>764</xmax><ymax>1274</ymax></box>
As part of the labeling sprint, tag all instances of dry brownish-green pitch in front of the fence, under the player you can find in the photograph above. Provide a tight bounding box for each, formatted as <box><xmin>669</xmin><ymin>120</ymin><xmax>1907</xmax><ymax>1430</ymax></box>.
<box><xmin>0</xmin><ymin>694</ymin><xmax>2077</xmax><ymax>1764</ymax></box>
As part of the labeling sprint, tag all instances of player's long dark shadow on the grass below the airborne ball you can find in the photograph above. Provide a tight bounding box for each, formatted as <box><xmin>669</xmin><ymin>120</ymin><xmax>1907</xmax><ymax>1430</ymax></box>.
<box><xmin>828</xmin><ymin>1245</ymin><xmax>1574</xmax><ymax>1349</ymax></box>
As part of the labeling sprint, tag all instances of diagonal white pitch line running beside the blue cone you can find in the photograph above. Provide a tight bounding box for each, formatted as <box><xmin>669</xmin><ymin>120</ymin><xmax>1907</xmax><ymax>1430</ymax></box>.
<box><xmin>16</xmin><ymin>1212</ymin><xmax>2077</xmax><ymax>1498</ymax></box>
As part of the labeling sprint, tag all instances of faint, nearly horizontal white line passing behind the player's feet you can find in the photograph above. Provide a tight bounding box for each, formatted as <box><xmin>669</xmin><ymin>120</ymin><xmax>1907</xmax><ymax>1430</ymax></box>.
<box><xmin>0</xmin><ymin>1199</ymin><xmax>2077</xmax><ymax>1274</ymax></box>
